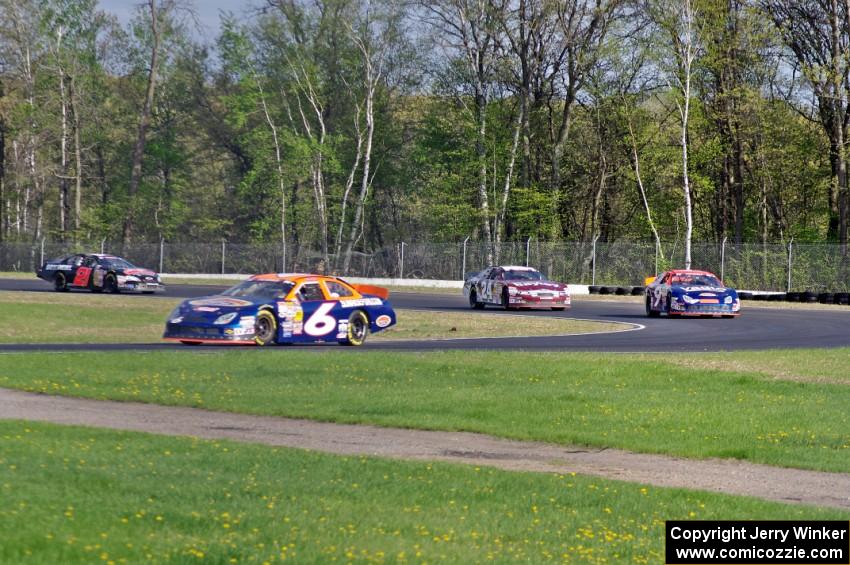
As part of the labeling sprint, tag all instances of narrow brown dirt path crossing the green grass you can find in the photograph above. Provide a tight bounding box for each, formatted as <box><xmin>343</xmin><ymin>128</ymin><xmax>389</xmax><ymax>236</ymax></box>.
<box><xmin>0</xmin><ymin>388</ymin><xmax>850</xmax><ymax>508</ymax></box>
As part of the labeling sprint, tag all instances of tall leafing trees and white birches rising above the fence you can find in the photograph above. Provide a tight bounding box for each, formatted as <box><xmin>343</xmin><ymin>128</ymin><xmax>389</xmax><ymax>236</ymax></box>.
<box><xmin>0</xmin><ymin>0</ymin><xmax>850</xmax><ymax>270</ymax></box>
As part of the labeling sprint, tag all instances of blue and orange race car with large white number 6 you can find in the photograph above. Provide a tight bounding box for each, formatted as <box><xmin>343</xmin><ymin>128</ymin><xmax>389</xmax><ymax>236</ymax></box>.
<box><xmin>162</xmin><ymin>274</ymin><xmax>396</xmax><ymax>345</ymax></box>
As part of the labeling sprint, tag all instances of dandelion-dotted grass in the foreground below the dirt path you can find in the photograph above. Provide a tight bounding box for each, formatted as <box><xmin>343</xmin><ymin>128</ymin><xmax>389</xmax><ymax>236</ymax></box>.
<box><xmin>0</xmin><ymin>421</ymin><xmax>846</xmax><ymax>563</ymax></box>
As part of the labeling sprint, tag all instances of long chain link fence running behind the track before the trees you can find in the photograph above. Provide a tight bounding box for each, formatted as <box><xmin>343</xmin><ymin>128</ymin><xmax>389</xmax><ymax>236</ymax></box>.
<box><xmin>0</xmin><ymin>239</ymin><xmax>850</xmax><ymax>291</ymax></box>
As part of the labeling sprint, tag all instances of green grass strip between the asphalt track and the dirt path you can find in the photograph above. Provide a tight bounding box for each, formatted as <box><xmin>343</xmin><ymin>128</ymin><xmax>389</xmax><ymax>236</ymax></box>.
<box><xmin>0</xmin><ymin>348</ymin><xmax>850</xmax><ymax>472</ymax></box>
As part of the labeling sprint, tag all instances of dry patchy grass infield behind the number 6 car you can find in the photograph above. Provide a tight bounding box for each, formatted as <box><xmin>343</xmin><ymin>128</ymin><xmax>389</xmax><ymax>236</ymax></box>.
<box><xmin>0</xmin><ymin>292</ymin><xmax>630</xmax><ymax>343</ymax></box>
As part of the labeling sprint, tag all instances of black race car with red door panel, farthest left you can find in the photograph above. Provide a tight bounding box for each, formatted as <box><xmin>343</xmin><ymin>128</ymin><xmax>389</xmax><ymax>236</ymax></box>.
<box><xmin>35</xmin><ymin>253</ymin><xmax>165</xmax><ymax>294</ymax></box>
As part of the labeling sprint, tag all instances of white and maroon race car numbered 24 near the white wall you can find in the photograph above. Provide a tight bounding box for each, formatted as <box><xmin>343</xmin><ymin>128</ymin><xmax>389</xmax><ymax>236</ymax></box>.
<box><xmin>463</xmin><ymin>266</ymin><xmax>570</xmax><ymax>310</ymax></box>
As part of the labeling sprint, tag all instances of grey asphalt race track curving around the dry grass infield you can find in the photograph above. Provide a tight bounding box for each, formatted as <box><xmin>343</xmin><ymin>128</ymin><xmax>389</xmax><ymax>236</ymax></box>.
<box><xmin>0</xmin><ymin>279</ymin><xmax>850</xmax><ymax>352</ymax></box>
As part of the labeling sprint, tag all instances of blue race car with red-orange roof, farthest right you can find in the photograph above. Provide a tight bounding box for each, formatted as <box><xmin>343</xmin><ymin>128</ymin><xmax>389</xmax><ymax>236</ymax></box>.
<box><xmin>646</xmin><ymin>270</ymin><xmax>741</xmax><ymax>318</ymax></box>
